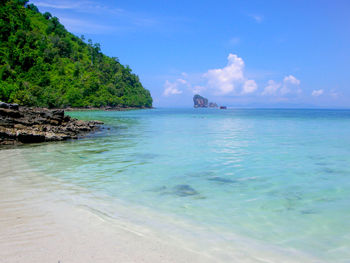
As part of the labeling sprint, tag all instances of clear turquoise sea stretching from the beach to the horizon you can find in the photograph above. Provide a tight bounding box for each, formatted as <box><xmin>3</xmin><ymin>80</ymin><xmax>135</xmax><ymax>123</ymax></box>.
<box><xmin>19</xmin><ymin>109</ymin><xmax>350</xmax><ymax>262</ymax></box>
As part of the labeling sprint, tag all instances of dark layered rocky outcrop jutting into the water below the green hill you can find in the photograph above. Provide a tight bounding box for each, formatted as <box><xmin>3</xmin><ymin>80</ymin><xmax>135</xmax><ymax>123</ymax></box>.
<box><xmin>0</xmin><ymin>102</ymin><xmax>103</xmax><ymax>144</ymax></box>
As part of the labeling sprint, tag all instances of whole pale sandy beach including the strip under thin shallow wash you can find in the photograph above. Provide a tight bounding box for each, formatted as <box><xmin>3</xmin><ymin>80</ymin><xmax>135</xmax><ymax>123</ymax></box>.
<box><xmin>0</xmin><ymin>149</ymin><xmax>320</xmax><ymax>263</ymax></box>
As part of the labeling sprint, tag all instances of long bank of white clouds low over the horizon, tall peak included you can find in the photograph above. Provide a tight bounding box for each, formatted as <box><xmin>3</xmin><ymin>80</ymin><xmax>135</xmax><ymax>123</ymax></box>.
<box><xmin>163</xmin><ymin>54</ymin><xmax>302</xmax><ymax>100</ymax></box>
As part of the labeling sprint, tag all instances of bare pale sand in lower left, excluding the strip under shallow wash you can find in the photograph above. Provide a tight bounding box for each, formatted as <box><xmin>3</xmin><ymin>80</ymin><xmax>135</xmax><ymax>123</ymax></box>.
<box><xmin>0</xmin><ymin>150</ymin><xmax>219</xmax><ymax>263</ymax></box>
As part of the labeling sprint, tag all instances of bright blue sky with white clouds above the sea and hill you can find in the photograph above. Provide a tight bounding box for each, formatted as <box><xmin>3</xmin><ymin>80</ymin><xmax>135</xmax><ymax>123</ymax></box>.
<box><xmin>31</xmin><ymin>0</ymin><xmax>350</xmax><ymax>108</ymax></box>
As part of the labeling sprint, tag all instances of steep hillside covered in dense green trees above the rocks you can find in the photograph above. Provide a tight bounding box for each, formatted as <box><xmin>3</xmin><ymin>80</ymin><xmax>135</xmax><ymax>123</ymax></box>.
<box><xmin>0</xmin><ymin>0</ymin><xmax>152</xmax><ymax>107</ymax></box>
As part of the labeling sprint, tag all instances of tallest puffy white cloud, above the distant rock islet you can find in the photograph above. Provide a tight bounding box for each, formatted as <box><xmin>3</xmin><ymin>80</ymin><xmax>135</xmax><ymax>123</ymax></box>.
<box><xmin>203</xmin><ymin>54</ymin><xmax>257</xmax><ymax>95</ymax></box>
